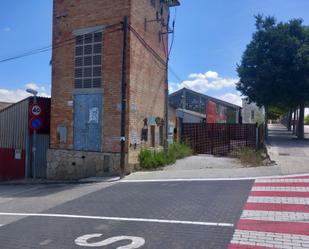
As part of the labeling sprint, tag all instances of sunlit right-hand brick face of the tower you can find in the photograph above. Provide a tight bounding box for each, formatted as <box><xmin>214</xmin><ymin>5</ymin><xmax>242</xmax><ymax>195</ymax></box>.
<box><xmin>129</xmin><ymin>0</ymin><xmax>168</xmax><ymax>163</ymax></box>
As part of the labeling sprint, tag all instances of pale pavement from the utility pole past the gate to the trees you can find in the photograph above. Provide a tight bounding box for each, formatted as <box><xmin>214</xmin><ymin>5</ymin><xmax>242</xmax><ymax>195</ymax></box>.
<box><xmin>125</xmin><ymin>125</ymin><xmax>309</xmax><ymax>181</ymax></box>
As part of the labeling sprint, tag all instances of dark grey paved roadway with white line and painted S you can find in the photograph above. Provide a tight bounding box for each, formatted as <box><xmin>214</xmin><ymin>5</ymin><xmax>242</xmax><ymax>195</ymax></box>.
<box><xmin>0</xmin><ymin>180</ymin><xmax>253</xmax><ymax>249</ymax></box>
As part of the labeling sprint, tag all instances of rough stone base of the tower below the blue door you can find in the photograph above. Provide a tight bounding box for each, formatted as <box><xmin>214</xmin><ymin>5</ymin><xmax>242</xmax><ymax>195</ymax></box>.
<box><xmin>47</xmin><ymin>149</ymin><xmax>124</xmax><ymax>180</ymax></box>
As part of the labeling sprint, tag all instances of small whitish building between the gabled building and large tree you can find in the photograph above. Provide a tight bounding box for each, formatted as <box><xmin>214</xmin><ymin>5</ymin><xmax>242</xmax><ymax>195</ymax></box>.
<box><xmin>242</xmin><ymin>98</ymin><xmax>265</xmax><ymax>124</ymax></box>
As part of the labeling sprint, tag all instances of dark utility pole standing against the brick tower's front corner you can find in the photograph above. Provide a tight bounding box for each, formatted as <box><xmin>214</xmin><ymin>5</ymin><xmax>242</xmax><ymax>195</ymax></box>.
<box><xmin>120</xmin><ymin>16</ymin><xmax>128</xmax><ymax>178</ymax></box>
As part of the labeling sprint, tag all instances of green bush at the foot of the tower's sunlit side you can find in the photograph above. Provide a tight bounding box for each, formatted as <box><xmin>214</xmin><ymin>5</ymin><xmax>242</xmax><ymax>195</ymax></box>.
<box><xmin>138</xmin><ymin>143</ymin><xmax>192</xmax><ymax>169</ymax></box>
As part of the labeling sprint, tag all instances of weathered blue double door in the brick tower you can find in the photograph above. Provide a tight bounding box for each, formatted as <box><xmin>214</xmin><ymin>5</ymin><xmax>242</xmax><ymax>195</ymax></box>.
<box><xmin>74</xmin><ymin>94</ymin><xmax>102</xmax><ymax>151</ymax></box>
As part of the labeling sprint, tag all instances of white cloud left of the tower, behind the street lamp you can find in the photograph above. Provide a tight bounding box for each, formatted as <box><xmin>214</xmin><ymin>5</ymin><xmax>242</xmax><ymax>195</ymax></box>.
<box><xmin>0</xmin><ymin>83</ymin><xmax>50</xmax><ymax>103</ymax></box>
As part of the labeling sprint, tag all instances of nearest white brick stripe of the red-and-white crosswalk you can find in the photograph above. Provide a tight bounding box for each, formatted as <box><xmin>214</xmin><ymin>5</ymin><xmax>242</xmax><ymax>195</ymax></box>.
<box><xmin>231</xmin><ymin>230</ymin><xmax>309</xmax><ymax>249</ymax></box>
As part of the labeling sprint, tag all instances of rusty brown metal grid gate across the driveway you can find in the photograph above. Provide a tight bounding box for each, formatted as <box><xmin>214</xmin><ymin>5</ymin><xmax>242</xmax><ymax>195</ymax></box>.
<box><xmin>181</xmin><ymin>123</ymin><xmax>264</xmax><ymax>155</ymax></box>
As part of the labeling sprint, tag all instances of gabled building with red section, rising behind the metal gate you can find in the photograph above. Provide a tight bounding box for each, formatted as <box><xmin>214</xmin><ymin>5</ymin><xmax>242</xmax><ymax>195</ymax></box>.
<box><xmin>169</xmin><ymin>88</ymin><xmax>241</xmax><ymax>124</ymax></box>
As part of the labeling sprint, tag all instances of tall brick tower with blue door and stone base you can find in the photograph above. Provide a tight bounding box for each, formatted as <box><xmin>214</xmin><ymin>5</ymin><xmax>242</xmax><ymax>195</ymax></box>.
<box><xmin>47</xmin><ymin>0</ymin><xmax>179</xmax><ymax>179</ymax></box>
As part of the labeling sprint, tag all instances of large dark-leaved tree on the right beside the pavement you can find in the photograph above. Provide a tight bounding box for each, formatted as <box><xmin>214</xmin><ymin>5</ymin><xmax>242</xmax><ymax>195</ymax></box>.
<box><xmin>237</xmin><ymin>15</ymin><xmax>309</xmax><ymax>138</ymax></box>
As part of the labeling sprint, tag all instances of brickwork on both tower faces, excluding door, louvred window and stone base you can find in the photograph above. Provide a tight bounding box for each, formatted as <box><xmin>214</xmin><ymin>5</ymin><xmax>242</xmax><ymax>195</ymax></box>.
<box><xmin>51</xmin><ymin>0</ymin><xmax>168</xmax><ymax>161</ymax></box>
